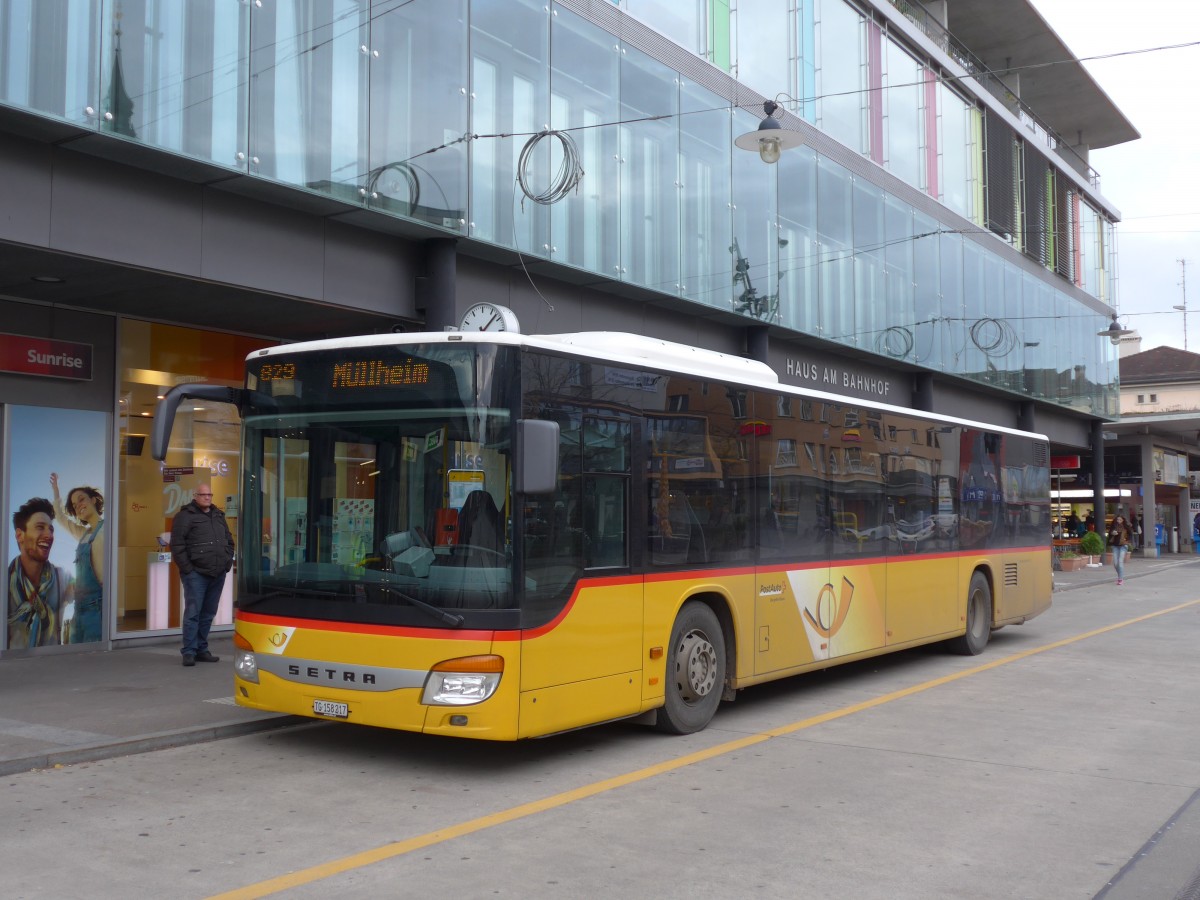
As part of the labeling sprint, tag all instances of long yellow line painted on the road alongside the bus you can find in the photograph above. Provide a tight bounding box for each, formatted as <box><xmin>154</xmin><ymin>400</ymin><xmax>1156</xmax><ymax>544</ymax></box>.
<box><xmin>212</xmin><ymin>599</ymin><xmax>1200</xmax><ymax>900</ymax></box>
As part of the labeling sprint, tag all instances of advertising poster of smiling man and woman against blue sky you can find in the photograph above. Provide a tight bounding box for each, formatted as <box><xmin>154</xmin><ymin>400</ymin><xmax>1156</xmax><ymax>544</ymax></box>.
<box><xmin>5</xmin><ymin>406</ymin><xmax>108</xmax><ymax>649</ymax></box>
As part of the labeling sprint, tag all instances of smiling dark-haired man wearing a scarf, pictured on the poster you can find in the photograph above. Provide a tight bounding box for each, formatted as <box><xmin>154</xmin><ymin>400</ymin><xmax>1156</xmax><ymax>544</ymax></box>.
<box><xmin>8</xmin><ymin>497</ymin><xmax>74</xmax><ymax>649</ymax></box>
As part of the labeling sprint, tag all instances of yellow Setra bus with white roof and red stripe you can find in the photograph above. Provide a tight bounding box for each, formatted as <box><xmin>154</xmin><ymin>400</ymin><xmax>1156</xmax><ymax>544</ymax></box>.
<box><xmin>154</xmin><ymin>332</ymin><xmax>1051</xmax><ymax>740</ymax></box>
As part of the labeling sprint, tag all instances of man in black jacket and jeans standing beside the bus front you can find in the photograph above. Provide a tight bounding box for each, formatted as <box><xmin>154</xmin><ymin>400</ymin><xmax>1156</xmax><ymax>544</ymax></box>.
<box><xmin>170</xmin><ymin>485</ymin><xmax>233</xmax><ymax>666</ymax></box>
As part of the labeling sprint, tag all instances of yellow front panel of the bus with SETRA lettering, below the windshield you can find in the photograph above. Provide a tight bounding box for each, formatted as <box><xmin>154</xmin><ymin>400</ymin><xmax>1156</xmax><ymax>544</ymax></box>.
<box><xmin>234</xmin><ymin>617</ymin><xmax>520</xmax><ymax>740</ymax></box>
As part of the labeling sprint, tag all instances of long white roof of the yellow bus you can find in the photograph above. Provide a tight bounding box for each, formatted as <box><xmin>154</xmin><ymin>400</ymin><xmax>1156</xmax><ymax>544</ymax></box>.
<box><xmin>253</xmin><ymin>331</ymin><xmax>1048</xmax><ymax>440</ymax></box>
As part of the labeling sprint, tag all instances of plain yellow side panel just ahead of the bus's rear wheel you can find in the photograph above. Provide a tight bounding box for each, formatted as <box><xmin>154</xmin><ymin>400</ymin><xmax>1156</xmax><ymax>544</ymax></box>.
<box><xmin>887</xmin><ymin>556</ymin><xmax>965</xmax><ymax>644</ymax></box>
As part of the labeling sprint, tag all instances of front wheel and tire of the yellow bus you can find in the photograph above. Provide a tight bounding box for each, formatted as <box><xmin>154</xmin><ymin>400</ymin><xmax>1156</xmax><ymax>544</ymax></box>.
<box><xmin>655</xmin><ymin>601</ymin><xmax>726</xmax><ymax>734</ymax></box>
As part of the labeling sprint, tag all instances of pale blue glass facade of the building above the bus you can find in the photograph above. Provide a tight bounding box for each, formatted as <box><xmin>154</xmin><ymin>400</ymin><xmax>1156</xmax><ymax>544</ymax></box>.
<box><xmin>0</xmin><ymin>0</ymin><xmax>1116</xmax><ymax>414</ymax></box>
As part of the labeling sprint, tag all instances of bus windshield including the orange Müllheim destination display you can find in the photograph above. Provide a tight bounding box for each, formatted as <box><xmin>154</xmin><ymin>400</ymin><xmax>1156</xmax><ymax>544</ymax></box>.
<box><xmin>238</xmin><ymin>344</ymin><xmax>518</xmax><ymax>628</ymax></box>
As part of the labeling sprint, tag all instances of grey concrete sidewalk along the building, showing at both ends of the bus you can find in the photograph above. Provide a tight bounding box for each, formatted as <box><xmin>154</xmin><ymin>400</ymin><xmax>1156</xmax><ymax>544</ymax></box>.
<box><xmin>0</xmin><ymin>554</ymin><xmax>1200</xmax><ymax>775</ymax></box>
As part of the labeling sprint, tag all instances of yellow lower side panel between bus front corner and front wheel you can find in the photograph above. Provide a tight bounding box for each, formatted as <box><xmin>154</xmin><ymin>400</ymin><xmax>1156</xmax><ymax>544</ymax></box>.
<box><xmin>521</xmin><ymin>577</ymin><xmax>642</xmax><ymax>734</ymax></box>
